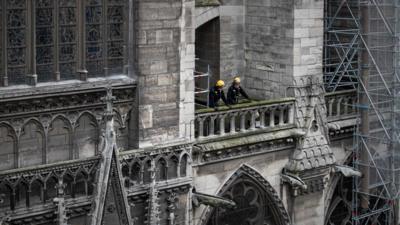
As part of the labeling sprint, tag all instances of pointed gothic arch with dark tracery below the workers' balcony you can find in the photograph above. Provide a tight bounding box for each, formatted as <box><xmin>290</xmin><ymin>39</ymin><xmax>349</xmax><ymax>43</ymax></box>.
<box><xmin>200</xmin><ymin>165</ymin><xmax>290</xmax><ymax>225</ymax></box>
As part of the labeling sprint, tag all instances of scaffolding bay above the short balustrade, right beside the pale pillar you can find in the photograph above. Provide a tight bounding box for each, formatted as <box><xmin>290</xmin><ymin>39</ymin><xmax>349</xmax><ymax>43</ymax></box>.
<box><xmin>323</xmin><ymin>0</ymin><xmax>360</xmax><ymax>92</ymax></box>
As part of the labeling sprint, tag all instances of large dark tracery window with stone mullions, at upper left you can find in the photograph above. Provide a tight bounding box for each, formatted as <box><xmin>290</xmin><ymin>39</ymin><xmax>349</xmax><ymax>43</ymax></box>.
<box><xmin>0</xmin><ymin>0</ymin><xmax>133</xmax><ymax>86</ymax></box>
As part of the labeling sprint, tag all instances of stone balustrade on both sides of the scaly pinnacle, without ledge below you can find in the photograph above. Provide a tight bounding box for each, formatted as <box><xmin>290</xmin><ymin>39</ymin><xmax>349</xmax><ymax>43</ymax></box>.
<box><xmin>195</xmin><ymin>90</ymin><xmax>357</xmax><ymax>143</ymax></box>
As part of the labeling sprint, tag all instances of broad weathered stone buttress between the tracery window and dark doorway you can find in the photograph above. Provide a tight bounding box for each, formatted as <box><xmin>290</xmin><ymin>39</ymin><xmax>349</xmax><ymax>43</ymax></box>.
<box><xmin>136</xmin><ymin>0</ymin><xmax>194</xmax><ymax>146</ymax></box>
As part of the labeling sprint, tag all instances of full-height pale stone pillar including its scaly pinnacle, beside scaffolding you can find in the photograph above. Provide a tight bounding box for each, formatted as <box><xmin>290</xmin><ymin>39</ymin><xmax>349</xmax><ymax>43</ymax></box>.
<box><xmin>286</xmin><ymin>0</ymin><xmax>335</xmax><ymax>225</ymax></box>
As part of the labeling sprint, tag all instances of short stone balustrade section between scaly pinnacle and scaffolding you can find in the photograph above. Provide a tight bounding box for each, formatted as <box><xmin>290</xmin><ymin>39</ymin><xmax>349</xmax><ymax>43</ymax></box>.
<box><xmin>325</xmin><ymin>90</ymin><xmax>357</xmax><ymax>121</ymax></box>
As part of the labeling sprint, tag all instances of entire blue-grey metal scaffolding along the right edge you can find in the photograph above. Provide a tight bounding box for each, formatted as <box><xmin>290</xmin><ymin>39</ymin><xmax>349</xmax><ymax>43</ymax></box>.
<box><xmin>324</xmin><ymin>0</ymin><xmax>400</xmax><ymax>225</ymax></box>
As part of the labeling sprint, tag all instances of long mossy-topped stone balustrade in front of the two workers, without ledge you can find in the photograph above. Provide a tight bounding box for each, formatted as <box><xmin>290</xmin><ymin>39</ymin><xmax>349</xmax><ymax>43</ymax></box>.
<box><xmin>195</xmin><ymin>98</ymin><xmax>295</xmax><ymax>139</ymax></box>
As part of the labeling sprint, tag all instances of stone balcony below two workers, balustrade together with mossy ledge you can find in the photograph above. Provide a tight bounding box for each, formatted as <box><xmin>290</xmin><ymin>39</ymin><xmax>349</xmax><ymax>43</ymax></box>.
<box><xmin>193</xmin><ymin>98</ymin><xmax>302</xmax><ymax>165</ymax></box>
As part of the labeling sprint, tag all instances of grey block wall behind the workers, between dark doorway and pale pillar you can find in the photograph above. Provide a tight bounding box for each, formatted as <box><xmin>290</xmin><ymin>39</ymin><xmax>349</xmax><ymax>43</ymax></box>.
<box><xmin>245</xmin><ymin>0</ymin><xmax>294</xmax><ymax>99</ymax></box>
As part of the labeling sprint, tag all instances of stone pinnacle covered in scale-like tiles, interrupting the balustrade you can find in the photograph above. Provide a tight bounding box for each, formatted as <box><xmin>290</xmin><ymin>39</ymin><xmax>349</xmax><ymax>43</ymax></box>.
<box><xmin>286</xmin><ymin>78</ymin><xmax>336</xmax><ymax>173</ymax></box>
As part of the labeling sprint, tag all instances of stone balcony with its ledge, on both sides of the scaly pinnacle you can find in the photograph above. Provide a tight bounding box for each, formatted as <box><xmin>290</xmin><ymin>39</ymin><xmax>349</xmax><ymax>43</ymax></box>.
<box><xmin>193</xmin><ymin>90</ymin><xmax>357</xmax><ymax>165</ymax></box>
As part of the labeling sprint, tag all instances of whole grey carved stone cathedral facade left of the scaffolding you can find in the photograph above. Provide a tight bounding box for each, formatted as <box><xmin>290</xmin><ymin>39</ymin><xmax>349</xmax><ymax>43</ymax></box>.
<box><xmin>0</xmin><ymin>0</ymin><xmax>356</xmax><ymax>225</ymax></box>
